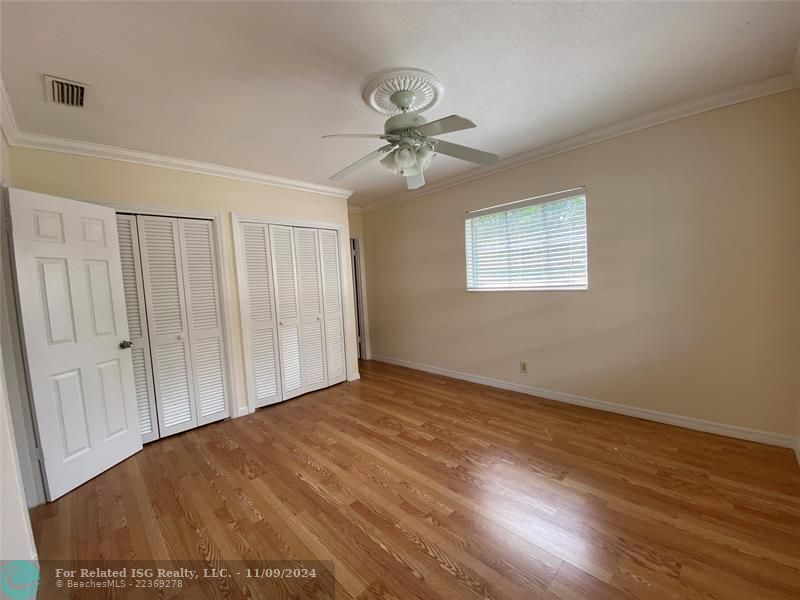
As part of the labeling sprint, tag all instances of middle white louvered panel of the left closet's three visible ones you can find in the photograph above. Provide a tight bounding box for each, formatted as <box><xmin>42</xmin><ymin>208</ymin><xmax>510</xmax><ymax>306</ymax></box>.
<box><xmin>136</xmin><ymin>215</ymin><xmax>198</xmax><ymax>437</ymax></box>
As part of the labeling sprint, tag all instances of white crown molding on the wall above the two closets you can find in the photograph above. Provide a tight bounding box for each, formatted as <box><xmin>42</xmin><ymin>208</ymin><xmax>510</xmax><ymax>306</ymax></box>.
<box><xmin>0</xmin><ymin>79</ymin><xmax>353</xmax><ymax>199</ymax></box>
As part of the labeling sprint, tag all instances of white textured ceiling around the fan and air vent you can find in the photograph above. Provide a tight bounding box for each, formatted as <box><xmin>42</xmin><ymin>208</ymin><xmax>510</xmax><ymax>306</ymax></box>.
<box><xmin>2</xmin><ymin>2</ymin><xmax>800</xmax><ymax>204</ymax></box>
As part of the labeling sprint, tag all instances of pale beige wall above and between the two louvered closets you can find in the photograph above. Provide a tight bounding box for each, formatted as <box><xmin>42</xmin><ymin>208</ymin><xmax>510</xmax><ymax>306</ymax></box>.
<box><xmin>10</xmin><ymin>146</ymin><xmax>358</xmax><ymax>418</ymax></box>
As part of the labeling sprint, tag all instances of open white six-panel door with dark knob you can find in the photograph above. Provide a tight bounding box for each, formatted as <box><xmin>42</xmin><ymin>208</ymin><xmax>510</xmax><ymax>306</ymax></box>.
<box><xmin>9</xmin><ymin>189</ymin><xmax>142</xmax><ymax>500</ymax></box>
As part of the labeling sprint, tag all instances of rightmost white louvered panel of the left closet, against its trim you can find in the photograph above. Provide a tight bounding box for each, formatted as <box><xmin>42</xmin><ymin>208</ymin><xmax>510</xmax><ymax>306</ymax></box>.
<box><xmin>178</xmin><ymin>219</ymin><xmax>229</xmax><ymax>425</ymax></box>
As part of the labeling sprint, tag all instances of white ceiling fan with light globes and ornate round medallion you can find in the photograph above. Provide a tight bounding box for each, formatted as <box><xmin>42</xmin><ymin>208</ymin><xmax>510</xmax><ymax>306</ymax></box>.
<box><xmin>322</xmin><ymin>69</ymin><xmax>499</xmax><ymax>190</ymax></box>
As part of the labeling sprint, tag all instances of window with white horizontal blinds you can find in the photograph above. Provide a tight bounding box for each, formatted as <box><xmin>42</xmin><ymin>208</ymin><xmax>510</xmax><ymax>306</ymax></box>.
<box><xmin>465</xmin><ymin>188</ymin><xmax>588</xmax><ymax>290</ymax></box>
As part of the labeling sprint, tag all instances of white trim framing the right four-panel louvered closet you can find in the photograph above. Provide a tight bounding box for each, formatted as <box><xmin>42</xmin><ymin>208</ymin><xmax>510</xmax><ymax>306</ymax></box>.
<box><xmin>231</xmin><ymin>212</ymin><xmax>359</xmax><ymax>415</ymax></box>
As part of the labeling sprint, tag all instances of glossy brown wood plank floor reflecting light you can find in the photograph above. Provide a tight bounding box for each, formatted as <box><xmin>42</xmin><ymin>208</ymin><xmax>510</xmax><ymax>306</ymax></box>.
<box><xmin>32</xmin><ymin>362</ymin><xmax>800</xmax><ymax>600</ymax></box>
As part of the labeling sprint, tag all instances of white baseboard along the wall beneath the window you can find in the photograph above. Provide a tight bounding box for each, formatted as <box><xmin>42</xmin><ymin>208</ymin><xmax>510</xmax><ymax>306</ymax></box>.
<box><xmin>372</xmin><ymin>355</ymin><xmax>800</xmax><ymax>448</ymax></box>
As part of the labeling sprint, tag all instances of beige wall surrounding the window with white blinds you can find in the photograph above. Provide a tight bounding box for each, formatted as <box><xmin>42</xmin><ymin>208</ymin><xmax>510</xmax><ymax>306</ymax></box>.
<box><xmin>363</xmin><ymin>91</ymin><xmax>800</xmax><ymax>435</ymax></box>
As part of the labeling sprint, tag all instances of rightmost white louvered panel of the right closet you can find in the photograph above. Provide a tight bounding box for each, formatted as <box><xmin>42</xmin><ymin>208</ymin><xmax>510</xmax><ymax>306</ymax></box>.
<box><xmin>319</xmin><ymin>229</ymin><xmax>347</xmax><ymax>385</ymax></box>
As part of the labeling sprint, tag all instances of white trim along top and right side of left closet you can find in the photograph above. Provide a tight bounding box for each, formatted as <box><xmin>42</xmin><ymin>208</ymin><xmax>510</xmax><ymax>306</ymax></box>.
<box><xmin>95</xmin><ymin>200</ymin><xmax>240</xmax><ymax>426</ymax></box>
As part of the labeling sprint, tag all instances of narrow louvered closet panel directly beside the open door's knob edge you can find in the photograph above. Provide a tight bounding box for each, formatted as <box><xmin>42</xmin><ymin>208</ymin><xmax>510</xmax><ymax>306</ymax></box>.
<box><xmin>117</xmin><ymin>215</ymin><xmax>159</xmax><ymax>443</ymax></box>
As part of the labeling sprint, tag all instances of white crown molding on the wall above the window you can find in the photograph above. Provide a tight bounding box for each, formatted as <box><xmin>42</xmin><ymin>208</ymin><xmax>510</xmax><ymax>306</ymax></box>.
<box><xmin>360</xmin><ymin>67</ymin><xmax>800</xmax><ymax>213</ymax></box>
